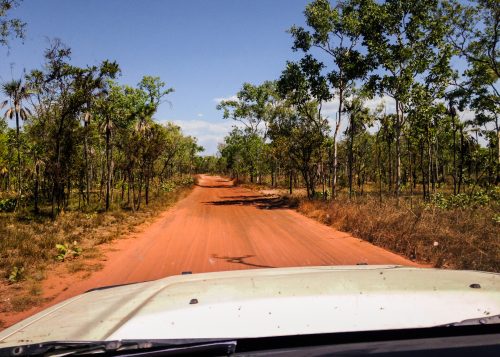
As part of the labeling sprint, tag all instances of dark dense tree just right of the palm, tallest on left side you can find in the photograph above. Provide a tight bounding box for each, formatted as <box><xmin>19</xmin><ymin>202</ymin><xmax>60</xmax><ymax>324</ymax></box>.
<box><xmin>29</xmin><ymin>40</ymin><xmax>119</xmax><ymax>215</ymax></box>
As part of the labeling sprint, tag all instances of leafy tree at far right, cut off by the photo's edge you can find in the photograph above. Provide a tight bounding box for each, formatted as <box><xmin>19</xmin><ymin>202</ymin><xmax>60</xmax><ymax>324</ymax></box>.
<box><xmin>446</xmin><ymin>0</ymin><xmax>500</xmax><ymax>183</ymax></box>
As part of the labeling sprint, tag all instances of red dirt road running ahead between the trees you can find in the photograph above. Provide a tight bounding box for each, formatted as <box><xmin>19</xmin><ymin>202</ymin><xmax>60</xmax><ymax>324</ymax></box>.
<box><xmin>2</xmin><ymin>176</ymin><xmax>417</xmax><ymax>327</ymax></box>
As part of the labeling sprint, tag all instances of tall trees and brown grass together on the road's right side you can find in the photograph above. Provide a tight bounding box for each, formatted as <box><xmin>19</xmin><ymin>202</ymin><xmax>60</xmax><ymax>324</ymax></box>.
<box><xmin>203</xmin><ymin>0</ymin><xmax>500</xmax><ymax>271</ymax></box>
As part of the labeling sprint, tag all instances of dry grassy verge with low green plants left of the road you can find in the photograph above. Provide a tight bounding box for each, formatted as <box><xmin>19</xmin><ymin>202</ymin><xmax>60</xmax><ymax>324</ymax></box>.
<box><xmin>0</xmin><ymin>180</ymin><xmax>192</xmax><ymax>284</ymax></box>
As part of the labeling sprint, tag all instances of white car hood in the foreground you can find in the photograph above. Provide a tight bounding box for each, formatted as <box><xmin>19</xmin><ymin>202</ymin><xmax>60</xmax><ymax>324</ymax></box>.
<box><xmin>0</xmin><ymin>266</ymin><xmax>500</xmax><ymax>348</ymax></box>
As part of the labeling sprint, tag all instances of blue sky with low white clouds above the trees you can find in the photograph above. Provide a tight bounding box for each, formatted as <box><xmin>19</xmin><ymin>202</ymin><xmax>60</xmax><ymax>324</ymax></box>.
<box><xmin>0</xmin><ymin>0</ymin><xmax>308</xmax><ymax>154</ymax></box>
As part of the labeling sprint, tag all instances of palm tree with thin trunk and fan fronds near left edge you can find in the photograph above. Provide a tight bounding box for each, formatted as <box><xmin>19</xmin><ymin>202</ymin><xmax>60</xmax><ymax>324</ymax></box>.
<box><xmin>0</xmin><ymin>79</ymin><xmax>31</xmax><ymax>209</ymax></box>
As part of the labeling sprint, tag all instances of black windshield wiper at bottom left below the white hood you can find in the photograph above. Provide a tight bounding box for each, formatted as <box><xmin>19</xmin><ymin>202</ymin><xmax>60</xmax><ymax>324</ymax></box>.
<box><xmin>0</xmin><ymin>339</ymin><xmax>236</xmax><ymax>357</ymax></box>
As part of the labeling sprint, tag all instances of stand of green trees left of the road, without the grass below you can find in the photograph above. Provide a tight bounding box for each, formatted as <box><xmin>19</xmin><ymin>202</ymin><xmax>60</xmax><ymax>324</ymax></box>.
<box><xmin>0</xmin><ymin>40</ymin><xmax>203</xmax><ymax>217</ymax></box>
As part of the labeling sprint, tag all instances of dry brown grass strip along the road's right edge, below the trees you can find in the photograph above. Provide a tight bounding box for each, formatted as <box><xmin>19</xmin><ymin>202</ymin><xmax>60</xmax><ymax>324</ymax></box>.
<box><xmin>298</xmin><ymin>198</ymin><xmax>500</xmax><ymax>272</ymax></box>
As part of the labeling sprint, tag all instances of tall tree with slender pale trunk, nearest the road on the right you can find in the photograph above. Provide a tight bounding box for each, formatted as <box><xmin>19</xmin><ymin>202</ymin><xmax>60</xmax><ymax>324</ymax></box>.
<box><xmin>290</xmin><ymin>0</ymin><xmax>371</xmax><ymax>197</ymax></box>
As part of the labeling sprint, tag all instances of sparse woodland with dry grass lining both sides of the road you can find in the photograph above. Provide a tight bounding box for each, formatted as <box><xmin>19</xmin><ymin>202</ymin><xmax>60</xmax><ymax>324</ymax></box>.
<box><xmin>0</xmin><ymin>0</ymin><xmax>500</xmax><ymax>290</ymax></box>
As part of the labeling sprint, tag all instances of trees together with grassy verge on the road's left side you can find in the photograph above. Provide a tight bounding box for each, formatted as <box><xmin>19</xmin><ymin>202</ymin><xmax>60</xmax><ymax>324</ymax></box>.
<box><xmin>0</xmin><ymin>0</ymin><xmax>203</xmax><ymax>292</ymax></box>
